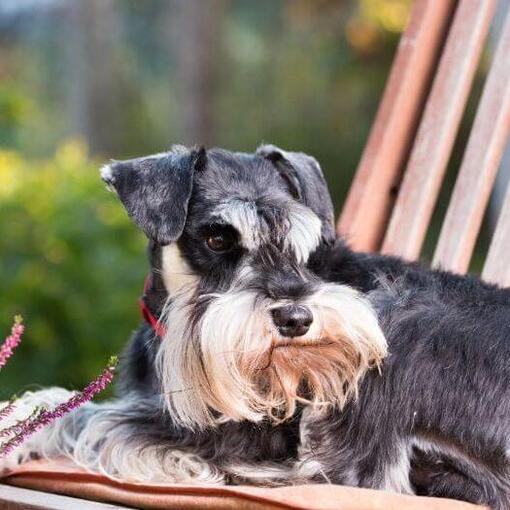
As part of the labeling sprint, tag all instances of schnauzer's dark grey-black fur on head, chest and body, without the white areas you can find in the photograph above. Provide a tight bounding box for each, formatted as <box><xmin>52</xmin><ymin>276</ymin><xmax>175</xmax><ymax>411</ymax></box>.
<box><xmin>101</xmin><ymin>145</ymin><xmax>510</xmax><ymax>509</ymax></box>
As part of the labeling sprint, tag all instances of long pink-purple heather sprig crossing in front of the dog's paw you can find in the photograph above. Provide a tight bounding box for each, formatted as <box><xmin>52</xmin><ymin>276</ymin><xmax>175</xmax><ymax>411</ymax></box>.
<box><xmin>0</xmin><ymin>356</ymin><xmax>117</xmax><ymax>457</ymax></box>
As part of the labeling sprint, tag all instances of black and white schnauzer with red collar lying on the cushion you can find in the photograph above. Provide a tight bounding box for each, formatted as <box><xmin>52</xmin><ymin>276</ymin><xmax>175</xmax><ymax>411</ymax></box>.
<box><xmin>2</xmin><ymin>145</ymin><xmax>510</xmax><ymax>509</ymax></box>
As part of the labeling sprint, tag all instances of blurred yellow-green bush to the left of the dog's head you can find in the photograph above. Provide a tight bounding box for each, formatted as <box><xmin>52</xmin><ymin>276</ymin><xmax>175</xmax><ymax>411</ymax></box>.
<box><xmin>0</xmin><ymin>141</ymin><xmax>146</xmax><ymax>397</ymax></box>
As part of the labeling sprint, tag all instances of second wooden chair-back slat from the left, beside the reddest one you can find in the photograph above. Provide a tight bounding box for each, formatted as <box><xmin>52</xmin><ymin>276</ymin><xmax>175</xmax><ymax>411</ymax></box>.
<box><xmin>382</xmin><ymin>0</ymin><xmax>496</xmax><ymax>260</ymax></box>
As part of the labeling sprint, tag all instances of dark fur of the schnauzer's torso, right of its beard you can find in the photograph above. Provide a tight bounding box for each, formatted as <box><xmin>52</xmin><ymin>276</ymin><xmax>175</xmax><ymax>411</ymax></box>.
<box><xmin>314</xmin><ymin>249</ymin><xmax>510</xmax><ymax>508</ymax></box>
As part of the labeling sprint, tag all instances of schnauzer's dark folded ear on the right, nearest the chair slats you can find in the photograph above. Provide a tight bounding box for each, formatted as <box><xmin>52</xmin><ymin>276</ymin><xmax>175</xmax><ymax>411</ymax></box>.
<box><xmin>257</xmin><ymin>145</ymin><xmax>335</xmax><ymax>241</ymax></box>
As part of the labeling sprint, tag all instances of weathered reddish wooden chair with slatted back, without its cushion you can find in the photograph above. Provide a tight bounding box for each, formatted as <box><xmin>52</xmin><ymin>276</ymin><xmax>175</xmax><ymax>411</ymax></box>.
<box><xmin>0</xmin><ymin>0</ymin><xmax>510</xmax><ymax>510</ymax></box>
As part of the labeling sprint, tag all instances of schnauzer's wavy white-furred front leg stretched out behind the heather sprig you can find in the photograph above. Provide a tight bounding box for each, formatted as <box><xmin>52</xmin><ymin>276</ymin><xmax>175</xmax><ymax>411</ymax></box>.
<box><xmin>0</xmin><ymin>388</ymin><xmax>228</xmax><ymax>484</ymax></box>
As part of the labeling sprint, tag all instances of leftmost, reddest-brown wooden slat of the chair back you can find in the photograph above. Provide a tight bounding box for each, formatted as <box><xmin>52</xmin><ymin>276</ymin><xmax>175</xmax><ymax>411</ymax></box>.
<box><xmin>338</xmin><ymin>0</ymin><xmax>457</xmax><ymax>251</ymax></box>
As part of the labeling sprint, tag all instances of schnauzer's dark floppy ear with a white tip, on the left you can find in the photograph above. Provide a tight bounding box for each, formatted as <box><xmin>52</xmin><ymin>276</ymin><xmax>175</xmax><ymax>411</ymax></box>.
<box><xmin>101</xmin><ymin>148</ymin><xmax>206</xmax><ymax>245</ymax></box>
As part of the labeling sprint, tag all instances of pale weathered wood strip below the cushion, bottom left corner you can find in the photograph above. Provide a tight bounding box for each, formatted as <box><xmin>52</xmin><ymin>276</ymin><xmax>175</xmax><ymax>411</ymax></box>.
<box><xmin>0</xmin><ymin>485</ymin><xmax>127</xmax><ymax>510</ymax></box>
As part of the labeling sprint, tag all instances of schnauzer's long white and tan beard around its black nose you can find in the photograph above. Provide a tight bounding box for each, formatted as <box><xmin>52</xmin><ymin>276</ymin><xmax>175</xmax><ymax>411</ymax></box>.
<box><xmin>157</xmin><ymin>284</ymin><xmax>386</xmax><ymax>429</ymax></box>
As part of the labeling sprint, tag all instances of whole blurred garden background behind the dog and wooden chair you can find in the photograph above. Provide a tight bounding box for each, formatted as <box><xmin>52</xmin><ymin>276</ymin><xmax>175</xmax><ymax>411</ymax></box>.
<box><xmin>0</xmin><ymin>0</ymin><xmax>510</xmax><ymax>398</ymax></box>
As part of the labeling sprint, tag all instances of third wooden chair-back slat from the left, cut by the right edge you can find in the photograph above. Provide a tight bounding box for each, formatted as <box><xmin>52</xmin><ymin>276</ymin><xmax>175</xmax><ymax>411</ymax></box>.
<box><xmin>433</xmin><ymin>10</ymin><xmax>510</xmax><ymax>273</ymax></box>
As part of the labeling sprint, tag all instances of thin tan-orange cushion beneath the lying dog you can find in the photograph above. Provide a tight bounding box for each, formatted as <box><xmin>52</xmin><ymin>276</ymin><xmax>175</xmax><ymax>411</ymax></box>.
<box><xmin>4</xmin><ymin>461</ymin><xmax>480</xmax><ymax>510</ymax></box>
